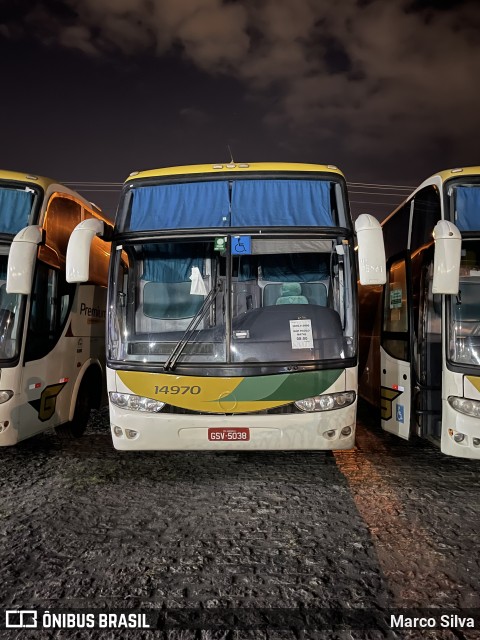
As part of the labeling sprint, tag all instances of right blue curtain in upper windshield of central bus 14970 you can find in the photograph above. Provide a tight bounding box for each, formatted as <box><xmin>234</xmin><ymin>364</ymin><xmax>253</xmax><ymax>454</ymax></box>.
<box><xmin>231</xmin><ymin>180</ymin><xmax>334</xmax><ymax>227</ymax></box>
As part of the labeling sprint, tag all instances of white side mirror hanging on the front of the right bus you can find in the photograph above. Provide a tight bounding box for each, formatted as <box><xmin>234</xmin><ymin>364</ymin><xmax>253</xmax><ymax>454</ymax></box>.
<box><xmin>432</xmin><ymin>220</ymin><xmax>462</xmax><ymax>294</ymax></box>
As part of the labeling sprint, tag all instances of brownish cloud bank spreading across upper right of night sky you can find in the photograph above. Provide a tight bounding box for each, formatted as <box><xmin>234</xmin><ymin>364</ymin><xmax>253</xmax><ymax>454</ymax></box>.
<box><xmin>0</xmin><ymin>0</ymin><xmax>480</xmax><ymax>196</ymax></box>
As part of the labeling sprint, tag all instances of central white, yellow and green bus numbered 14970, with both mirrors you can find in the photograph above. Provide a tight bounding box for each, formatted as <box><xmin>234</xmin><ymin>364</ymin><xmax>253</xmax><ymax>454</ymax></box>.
<box><xmin>67</xmin><ymin>163</ymin><xmax>385</xmax><ymax>450</ymax></box>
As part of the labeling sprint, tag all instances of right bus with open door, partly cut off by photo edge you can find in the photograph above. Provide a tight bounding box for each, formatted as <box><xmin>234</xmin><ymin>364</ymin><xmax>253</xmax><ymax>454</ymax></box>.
<box><xmin>360</xmin><ymin>167</ymin><xmax>480</xmax><ymax>458</ymax></box>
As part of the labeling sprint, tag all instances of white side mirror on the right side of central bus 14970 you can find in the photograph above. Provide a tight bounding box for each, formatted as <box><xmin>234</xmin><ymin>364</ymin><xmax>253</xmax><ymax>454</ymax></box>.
<box><xmin>355</xmin><ymin>213</ymin><xmax>387</xmax><ymax>285</ymax></box>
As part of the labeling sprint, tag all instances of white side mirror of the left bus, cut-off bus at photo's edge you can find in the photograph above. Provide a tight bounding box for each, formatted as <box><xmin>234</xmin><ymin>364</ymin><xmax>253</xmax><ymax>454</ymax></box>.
<box><xmin>6</xmin><ymin>225</ymin><xmax>43</xmax><ymax>295</ymax></box>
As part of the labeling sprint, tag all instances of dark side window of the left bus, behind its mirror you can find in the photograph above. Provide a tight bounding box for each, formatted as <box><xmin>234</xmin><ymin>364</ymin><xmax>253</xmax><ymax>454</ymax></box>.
<box><xmin>25</xmin><ymin>262</ymin><xmax>75</xmax><ymax>362</ymax></box>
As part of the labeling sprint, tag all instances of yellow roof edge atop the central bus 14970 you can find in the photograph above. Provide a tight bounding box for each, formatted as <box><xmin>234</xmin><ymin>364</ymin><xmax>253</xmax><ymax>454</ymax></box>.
<box><xmin>125</xmin><ymin>162</ymin><xmax>345</xmax><ymax>183</ymax></box>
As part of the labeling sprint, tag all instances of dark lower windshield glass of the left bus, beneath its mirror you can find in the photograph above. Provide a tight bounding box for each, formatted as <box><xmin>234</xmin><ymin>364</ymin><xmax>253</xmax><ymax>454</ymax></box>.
<box><xmin>0</xmin><ymin>254</ymin><xmax>24</xmax><ymax>366</ymax></box>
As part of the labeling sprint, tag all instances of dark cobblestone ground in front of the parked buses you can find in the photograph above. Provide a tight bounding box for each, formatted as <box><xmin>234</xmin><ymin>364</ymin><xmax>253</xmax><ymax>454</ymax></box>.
<box><xmin>0</xmin><ymin>412</ymin><xmax>480</xmax><ymax>640</ymax></box>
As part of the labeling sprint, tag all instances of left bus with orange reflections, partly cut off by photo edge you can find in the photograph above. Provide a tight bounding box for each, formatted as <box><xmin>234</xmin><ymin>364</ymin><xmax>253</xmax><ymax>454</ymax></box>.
<box><xmin>0</xmin><ymin>171</ymin><xmax>111</xmax><ymax>446</ymax></box>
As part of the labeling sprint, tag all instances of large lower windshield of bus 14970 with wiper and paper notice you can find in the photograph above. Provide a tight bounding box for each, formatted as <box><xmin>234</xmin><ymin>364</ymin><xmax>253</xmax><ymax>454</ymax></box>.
<box><xmin>109</xmin><ymin>235</ymin><xmax>356</xmax><ymax>368</ymax></box>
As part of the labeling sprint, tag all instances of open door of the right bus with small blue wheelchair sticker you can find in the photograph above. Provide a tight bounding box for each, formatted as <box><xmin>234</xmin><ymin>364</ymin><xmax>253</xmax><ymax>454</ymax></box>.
<box><xmin>380</xmin><ymin>253</ymin><xmax>412</xmax><ymax>440</ymax></box>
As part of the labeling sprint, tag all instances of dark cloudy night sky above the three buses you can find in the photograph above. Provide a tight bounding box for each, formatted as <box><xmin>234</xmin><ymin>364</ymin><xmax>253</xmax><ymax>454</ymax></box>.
<box><xmin>0</xmin><ymin>0</ymin><xmax>480</xmax><ymax>218</ymax></box>
